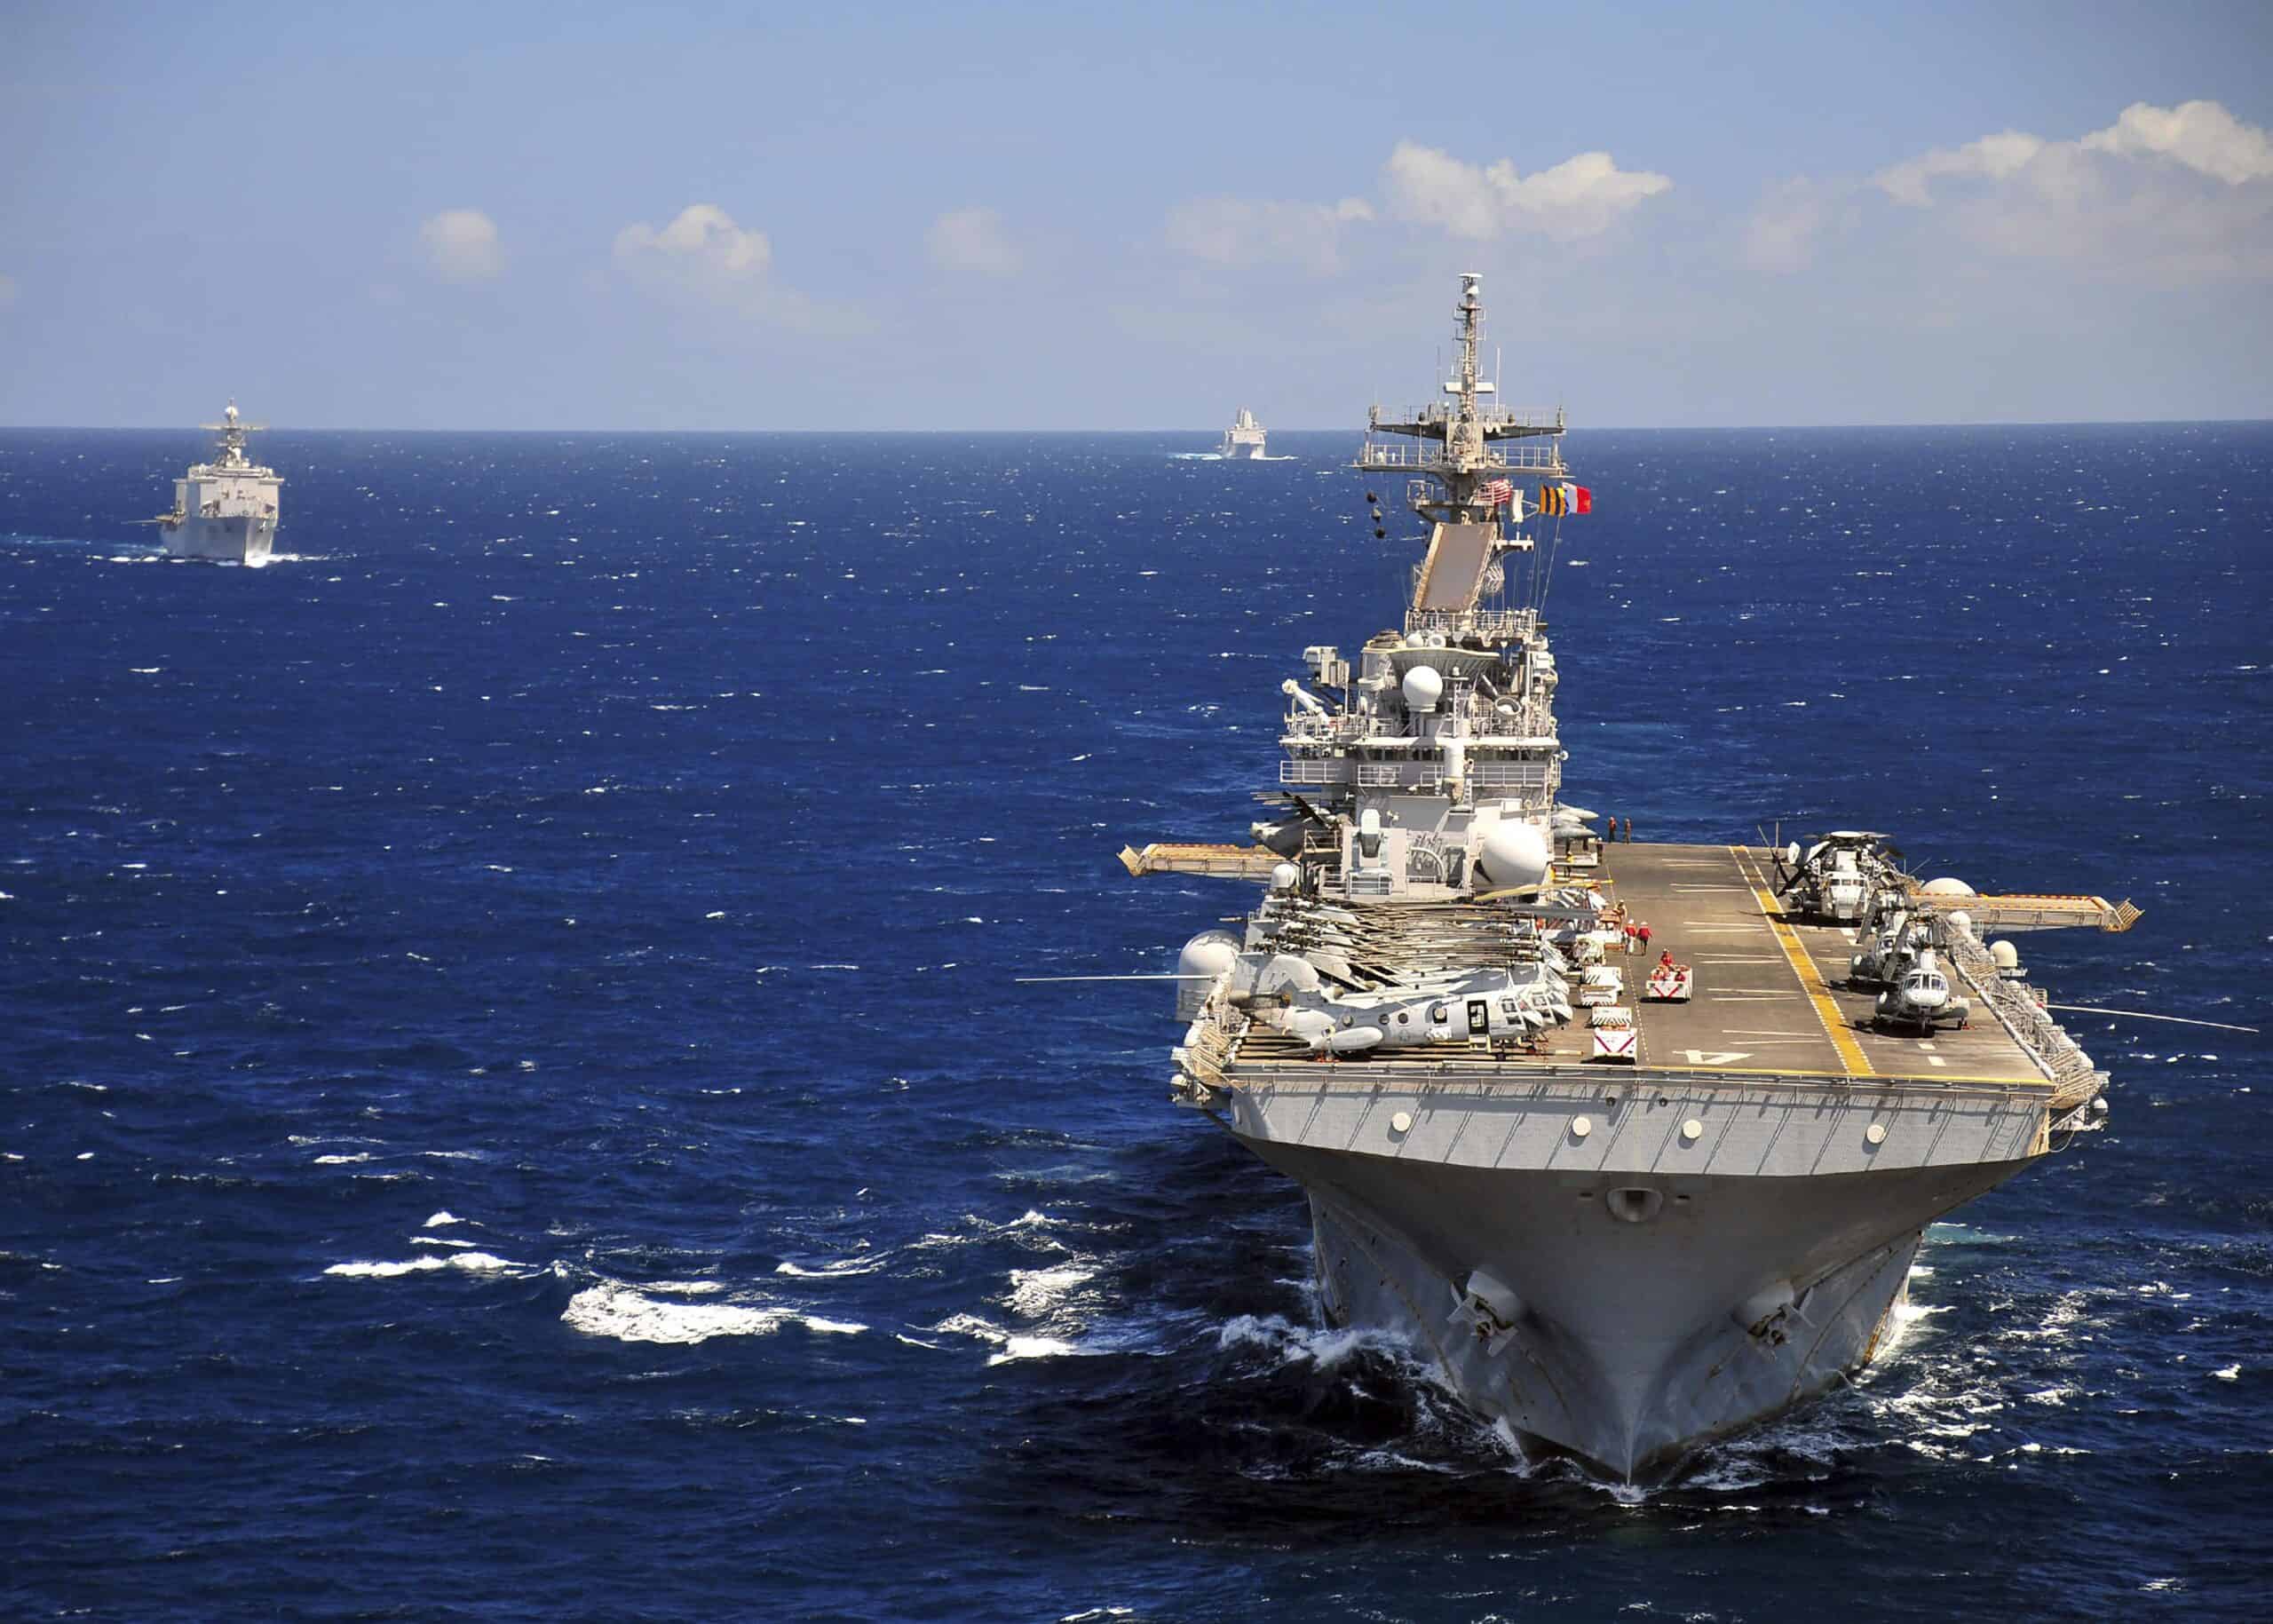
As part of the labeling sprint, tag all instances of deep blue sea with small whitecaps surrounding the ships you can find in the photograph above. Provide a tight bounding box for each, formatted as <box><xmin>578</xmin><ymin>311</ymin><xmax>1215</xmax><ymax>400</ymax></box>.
<box><xmin>0</xmin><ymin>425</ymin><xmax>2273</xmax><ymax>1624</ymax></box>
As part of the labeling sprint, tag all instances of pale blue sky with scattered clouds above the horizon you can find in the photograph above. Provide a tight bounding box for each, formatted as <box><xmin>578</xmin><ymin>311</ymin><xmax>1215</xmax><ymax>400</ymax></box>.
<box><xmin>0</xmin><ymin>0</ymin><xmax>2273</xmax><ymax>430</ymax></box>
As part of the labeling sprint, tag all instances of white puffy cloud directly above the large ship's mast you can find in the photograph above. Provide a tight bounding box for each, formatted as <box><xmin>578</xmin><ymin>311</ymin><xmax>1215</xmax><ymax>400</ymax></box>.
<box><xmin>1384</xmin><ymin>141</ymin><xmax>1673</xmax><ymax>242</ymax></box>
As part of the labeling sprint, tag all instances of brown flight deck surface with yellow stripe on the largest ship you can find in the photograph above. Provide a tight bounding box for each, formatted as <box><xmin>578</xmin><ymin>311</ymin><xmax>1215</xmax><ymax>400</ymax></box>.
<box><xmin>1225</xmin><ymin>844</ymin><xmax>2048</xmax><ymax>1087</ymax></box>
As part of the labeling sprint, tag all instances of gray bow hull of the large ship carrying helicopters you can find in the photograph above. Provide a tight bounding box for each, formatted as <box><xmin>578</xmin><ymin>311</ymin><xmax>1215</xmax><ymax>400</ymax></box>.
<box><xmin>1225</xmin><ymin>1066</ymin><xmax>2041</xmax><ymax>1478</ymax></box>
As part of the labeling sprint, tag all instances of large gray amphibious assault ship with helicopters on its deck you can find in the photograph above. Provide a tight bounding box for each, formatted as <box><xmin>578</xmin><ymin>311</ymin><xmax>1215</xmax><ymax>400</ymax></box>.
<box><xmin>1121</xmin><ymin>275</ymin><xmax>2136</xmax><ymax>1478</ymax></box>
